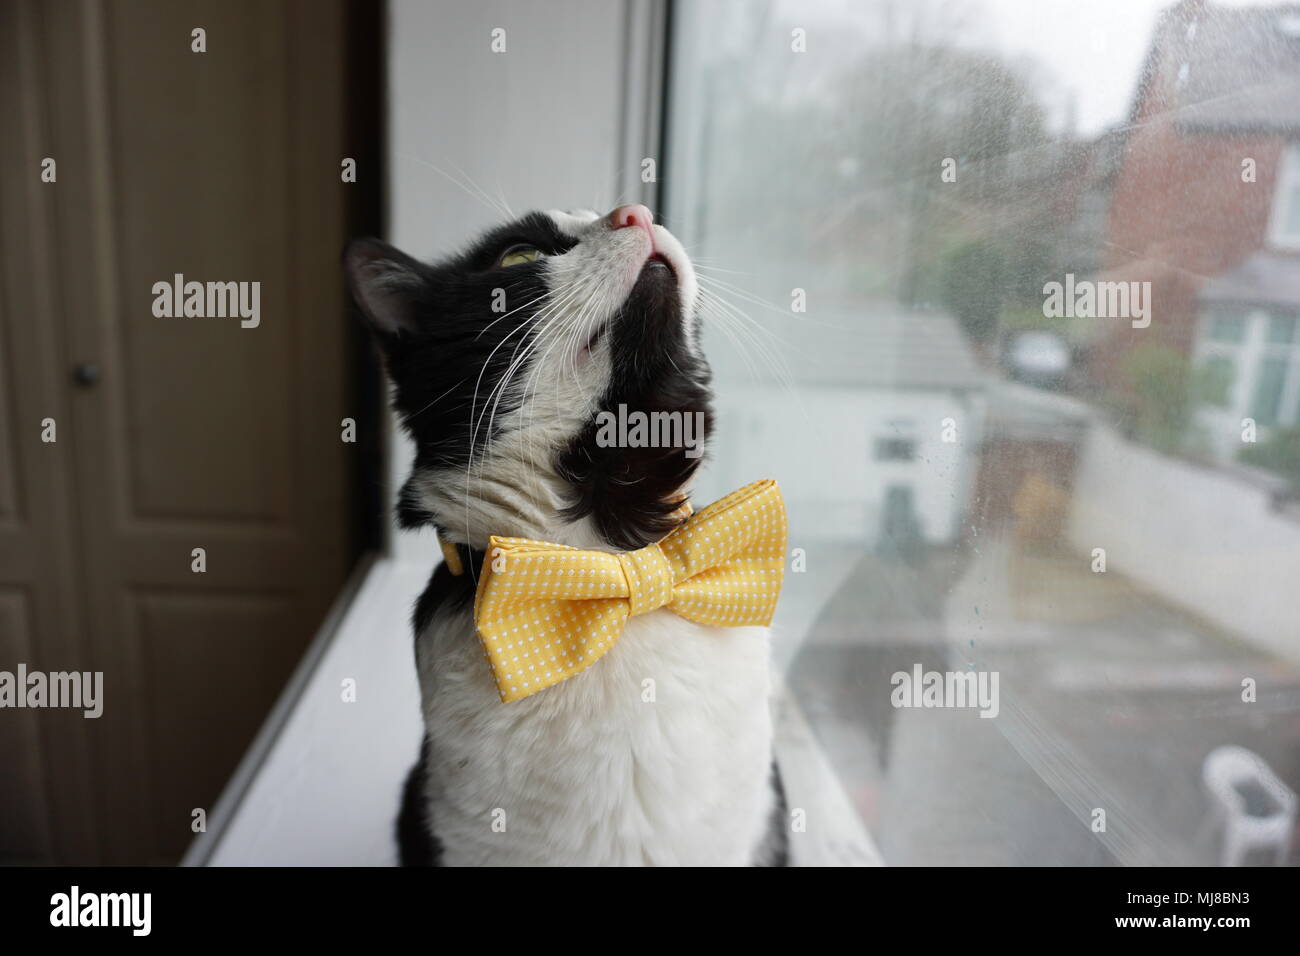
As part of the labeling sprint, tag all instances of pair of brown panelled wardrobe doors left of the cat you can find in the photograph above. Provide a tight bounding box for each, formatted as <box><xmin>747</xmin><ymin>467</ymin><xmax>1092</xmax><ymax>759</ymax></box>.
<box><xmin>0</xmin><ymin>0</ymin><xmax>356</xmax><ymax>862</ymax></box>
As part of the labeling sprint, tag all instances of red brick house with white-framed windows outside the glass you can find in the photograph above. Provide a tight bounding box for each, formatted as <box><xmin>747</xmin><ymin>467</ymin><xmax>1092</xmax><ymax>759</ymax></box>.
<box><xmin>1089</xmin><ymin>0</ymin><xmax>1300</xmax><ymax>458</ymax></box>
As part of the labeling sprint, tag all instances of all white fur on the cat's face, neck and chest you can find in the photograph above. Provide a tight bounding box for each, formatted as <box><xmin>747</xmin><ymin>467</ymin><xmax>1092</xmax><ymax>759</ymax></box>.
<box><xmin>416</xmin><ymin>212</ymin><xmax>772</xmax><ymax>865</ymax></box>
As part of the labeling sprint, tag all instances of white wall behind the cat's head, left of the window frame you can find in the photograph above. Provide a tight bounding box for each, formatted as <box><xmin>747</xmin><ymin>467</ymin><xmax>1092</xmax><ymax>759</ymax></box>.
<box><xmin>387</xmin><ymin>0</ymin><xmax>651</xmax><ymax>562</ymax></box>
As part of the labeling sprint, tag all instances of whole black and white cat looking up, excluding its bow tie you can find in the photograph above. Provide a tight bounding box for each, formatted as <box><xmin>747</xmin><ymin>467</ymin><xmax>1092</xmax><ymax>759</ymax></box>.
<box><xmin>345</xmin><ymin>206</ymin><xmax>787</xmax><ymax>865</ymax></box>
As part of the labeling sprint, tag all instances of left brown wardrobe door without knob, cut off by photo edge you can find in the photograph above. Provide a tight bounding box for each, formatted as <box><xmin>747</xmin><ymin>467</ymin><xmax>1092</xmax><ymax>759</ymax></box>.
<box><xmin>0</xmin><ymin>3</ymin><xmax>100</xmax><ymax>864</ymax></box>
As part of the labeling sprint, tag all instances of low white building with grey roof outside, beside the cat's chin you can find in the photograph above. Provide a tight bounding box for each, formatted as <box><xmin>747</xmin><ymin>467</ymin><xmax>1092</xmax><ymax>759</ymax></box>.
<box><xmin>699</xmin><ymin>302</ymin><xmax>985</xmax><ymax>548</ymax></box>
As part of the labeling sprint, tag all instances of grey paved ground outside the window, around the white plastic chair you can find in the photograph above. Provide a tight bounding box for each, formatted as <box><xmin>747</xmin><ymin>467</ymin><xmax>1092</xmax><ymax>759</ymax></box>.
<box><xmin>787</xmin><ymin>536</ymin><xmax>1300</xmax><ymax>865</ymax></box>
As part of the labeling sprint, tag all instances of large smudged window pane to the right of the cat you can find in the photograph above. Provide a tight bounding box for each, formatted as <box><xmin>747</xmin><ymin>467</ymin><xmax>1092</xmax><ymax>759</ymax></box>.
<box><xmin>662</xmin><ymin>0</ymin><xmax>1300</xmax><ymax>865</ymax></box>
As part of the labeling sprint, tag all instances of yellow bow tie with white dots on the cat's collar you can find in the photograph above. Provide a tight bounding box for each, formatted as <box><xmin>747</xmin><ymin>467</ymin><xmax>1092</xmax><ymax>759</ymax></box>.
<box><xmin>470</xmin><ymin>481</ymin><xmax>785</xmax><ymax>701</ymax></box>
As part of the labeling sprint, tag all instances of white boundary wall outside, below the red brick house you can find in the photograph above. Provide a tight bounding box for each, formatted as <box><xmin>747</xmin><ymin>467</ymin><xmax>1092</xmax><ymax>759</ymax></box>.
<box><xmin>1069</xmin><ymin>423</ymin><xmax>1300</xmax><ymax>659</ymax></box>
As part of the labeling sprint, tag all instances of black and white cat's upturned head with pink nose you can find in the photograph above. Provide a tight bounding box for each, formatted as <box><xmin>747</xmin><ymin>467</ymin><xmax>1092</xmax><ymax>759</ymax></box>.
<box><xmin>345</xmin><ymin>206</ymin><xmax>711</xmax><ymax>549</ymax></box>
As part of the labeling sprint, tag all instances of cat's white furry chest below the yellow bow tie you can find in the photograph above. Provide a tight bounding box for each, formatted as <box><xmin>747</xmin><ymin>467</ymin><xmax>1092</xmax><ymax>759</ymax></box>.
<box><xmin>417</xmin><ymin>609</ymin><xmax>771</xmax><ymax>864</ymax></box>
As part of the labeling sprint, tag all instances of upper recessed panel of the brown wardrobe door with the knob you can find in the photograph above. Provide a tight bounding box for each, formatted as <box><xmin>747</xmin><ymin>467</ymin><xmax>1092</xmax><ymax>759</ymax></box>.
<box><xmin>103</xmin><ymin>3</ymin><xmax>297</xmax><ymax>522</ymax></box>
